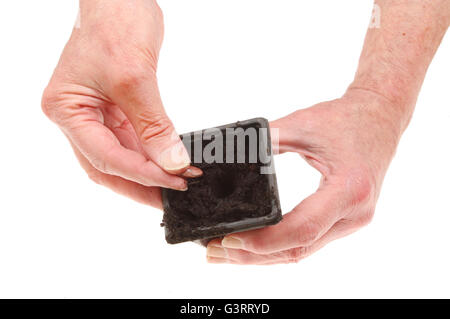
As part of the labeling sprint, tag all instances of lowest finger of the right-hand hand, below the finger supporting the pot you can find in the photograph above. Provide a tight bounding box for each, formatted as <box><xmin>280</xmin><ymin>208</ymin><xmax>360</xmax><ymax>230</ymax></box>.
<box><xmin>207</xmin><ymin>220</ymin><xmax>358</xmax><ymax>265</ymax></box>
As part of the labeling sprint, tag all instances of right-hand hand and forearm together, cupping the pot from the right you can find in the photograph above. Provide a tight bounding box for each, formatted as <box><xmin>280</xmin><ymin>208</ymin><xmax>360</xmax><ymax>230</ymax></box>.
<box><xmin>207</xmin><ymin>0</ymin><xmax>450</xmax><ymax>264</ymax></box>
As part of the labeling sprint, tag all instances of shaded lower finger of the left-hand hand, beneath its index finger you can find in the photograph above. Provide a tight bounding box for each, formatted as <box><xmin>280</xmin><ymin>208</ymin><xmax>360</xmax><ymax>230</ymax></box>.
<box><xmin>71</xmin><ymin>143</ymin><xmax>162</xmax><ymax>209</ymax></box>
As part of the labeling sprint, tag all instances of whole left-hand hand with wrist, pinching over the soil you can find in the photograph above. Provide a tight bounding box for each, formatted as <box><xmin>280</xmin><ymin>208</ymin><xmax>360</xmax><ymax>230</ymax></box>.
<box><xmin>42</xmin><ymin>0</ymin><xmax>201</xmax><ymax>207</ymax></box>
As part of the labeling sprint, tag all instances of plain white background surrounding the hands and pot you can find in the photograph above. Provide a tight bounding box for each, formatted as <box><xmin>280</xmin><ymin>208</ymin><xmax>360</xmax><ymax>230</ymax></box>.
<box><xmin>0</xmin><ymin>0</ymin><xmax>450</xmax><ymax>298</ymax></box>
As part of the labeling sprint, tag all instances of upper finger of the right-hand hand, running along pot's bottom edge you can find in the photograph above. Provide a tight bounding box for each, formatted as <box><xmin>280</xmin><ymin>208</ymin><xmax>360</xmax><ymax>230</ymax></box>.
<box><xmin>221</xmin><ymin>186</ymin><xmax>346</xmax><ymax>254</ymax></box>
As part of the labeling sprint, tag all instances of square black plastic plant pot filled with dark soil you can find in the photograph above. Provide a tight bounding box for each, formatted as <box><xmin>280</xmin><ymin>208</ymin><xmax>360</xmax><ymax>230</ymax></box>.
<box><xmin>162</xmin><ymin>118</ymin><xmax>282</xmax><ymax>244</ymax></box>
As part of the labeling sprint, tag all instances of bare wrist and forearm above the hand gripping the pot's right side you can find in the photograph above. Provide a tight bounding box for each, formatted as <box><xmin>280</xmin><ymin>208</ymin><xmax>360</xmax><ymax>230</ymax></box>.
<box><xmin>348</xmin><ymin>0</ymin><xmax>450</xmax><ymax>134</ymax></box>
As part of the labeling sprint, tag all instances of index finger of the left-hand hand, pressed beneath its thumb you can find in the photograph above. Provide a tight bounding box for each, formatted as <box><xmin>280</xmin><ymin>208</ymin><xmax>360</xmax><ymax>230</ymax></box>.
<box><xmin>63</xmin><ymin>114</ymin><xmax>187</xmax><ymax>190</ymax></box>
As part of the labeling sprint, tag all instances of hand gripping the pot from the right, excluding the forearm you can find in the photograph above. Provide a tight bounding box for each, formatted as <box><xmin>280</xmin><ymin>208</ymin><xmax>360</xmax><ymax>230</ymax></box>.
<box><xmin>207</xmin><ymin>89</ymin><xmax>401</xmax><ymax>264</ymax></box>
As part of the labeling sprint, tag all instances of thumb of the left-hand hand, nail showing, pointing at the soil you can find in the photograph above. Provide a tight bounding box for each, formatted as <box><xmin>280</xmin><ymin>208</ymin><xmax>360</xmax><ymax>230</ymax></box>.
<box><xmin>116</xmin><ymin>77</ymin><xmax>191</xmax><ymax>174</ymax></box>
